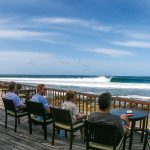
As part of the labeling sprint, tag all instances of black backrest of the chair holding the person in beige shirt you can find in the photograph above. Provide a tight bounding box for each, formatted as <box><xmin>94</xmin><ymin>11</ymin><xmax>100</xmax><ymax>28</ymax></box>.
<box><xmin>51</xmin><ymin>107</ymin><xmax>72</xmax><ymax>125</ymax></box>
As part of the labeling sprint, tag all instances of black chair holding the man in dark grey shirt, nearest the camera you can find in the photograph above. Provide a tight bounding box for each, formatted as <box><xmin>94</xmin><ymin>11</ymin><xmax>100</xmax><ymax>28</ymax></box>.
<box><xmin>85</xmin><ymin>121</ymin><xmax>126</xmax><ymax>150</ymax></box>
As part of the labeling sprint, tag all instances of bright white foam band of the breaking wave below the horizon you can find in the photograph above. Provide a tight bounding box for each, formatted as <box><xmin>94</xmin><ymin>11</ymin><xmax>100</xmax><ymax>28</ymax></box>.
<box><xmin>0</xmin><ymin>77</ymin><xmax>150</xmax><ymax>89</ymax></box>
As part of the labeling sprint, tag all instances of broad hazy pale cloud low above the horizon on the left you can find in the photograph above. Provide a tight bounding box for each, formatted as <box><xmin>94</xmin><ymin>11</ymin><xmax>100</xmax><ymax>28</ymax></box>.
<box><xmin>0</xmin><ymin>50</ymin><xmax>93</xmax><ymax>74</ymax></box>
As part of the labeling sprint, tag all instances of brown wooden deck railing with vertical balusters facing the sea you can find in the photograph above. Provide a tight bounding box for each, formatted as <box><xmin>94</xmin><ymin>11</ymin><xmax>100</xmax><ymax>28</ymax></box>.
<box><xmin>0</xmin><ymin>81</ymin><xmax>150</xmax><ymax>128</ymax></box>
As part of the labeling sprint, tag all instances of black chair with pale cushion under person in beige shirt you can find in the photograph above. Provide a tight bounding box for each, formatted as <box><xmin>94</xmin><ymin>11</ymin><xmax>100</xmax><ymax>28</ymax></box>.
<box><xmin>51</xmin><ymin>108</ymin><xmax>84</xmax><ymax>150</ymax></box>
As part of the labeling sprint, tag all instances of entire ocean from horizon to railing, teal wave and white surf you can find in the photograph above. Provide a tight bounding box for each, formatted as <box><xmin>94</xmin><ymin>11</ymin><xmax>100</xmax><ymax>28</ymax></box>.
<box><xmin>0</xmin><ymin>75</ymin><xmax>150</xmax><ymax>101</ymax></box>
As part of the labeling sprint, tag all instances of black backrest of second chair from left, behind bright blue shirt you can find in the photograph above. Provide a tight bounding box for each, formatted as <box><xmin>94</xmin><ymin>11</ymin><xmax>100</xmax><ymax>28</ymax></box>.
<box><xmin>26</xmin><ymin>100</ymin><xmax>45</xmax><ymax>115</ymax></box>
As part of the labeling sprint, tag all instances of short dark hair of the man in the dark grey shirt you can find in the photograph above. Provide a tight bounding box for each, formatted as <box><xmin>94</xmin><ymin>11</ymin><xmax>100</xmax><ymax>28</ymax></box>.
<box><xmin>98</xmin><ymin>92</ymin><xmax>112</xmax><ymax>110</ymax></box>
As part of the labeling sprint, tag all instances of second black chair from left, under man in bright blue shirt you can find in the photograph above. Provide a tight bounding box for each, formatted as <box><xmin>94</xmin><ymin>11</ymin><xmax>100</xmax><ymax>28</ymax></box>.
<box><xmin>26</xmin><ymin>100</ymin><xmax>53</xmax><ymax>139</ymax></box>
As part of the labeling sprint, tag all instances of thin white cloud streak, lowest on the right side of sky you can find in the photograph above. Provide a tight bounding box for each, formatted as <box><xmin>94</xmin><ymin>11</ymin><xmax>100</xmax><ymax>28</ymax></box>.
<box><xmin>91</xmin><ymin>48</ymin><xmax>134</xmax><ymax>57</ymax></box>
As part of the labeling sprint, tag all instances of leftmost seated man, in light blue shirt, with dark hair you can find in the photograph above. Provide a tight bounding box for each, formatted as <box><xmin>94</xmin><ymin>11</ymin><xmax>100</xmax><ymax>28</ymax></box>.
<box><xmin>4</xmin><ymin>82</ymin><xmax>26</xmax><ymax>110</ymax></box>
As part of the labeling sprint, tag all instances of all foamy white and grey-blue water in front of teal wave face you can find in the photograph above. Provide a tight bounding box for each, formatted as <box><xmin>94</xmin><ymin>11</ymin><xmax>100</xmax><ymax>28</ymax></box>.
<box><xmin>0</xmin><ymin>76</ymin><xmax>150</xmax><ymax>101</ymax></box>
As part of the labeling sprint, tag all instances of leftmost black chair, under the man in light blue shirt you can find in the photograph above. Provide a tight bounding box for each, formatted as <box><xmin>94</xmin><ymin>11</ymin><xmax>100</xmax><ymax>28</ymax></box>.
<box><xmin>2</xmin><ymin>98</ymin><xmax>28</xmax><ymax>132</ymax></box>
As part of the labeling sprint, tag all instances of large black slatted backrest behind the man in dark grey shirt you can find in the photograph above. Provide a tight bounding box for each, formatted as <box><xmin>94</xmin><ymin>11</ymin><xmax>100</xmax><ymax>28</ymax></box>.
<box><xmin>86</xmin><ymin>121</ymin><xmax>122</xmax><ymax>146</ymax></box>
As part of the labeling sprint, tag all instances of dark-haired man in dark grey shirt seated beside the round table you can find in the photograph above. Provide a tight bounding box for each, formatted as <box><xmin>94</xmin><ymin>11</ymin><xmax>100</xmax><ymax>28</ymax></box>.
<box><xmin>88</xmin><ymin>92</ymin><xmax>129</xmax><ymax>137</ymax></box>
